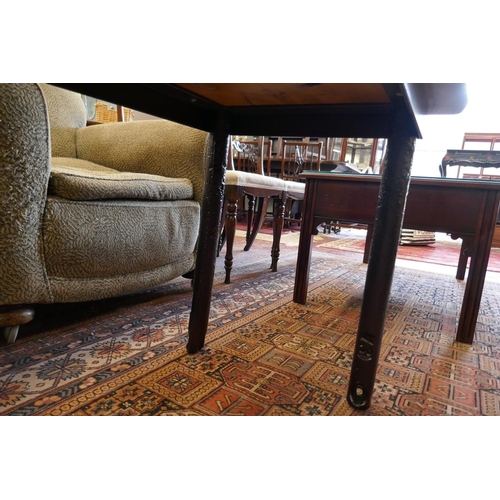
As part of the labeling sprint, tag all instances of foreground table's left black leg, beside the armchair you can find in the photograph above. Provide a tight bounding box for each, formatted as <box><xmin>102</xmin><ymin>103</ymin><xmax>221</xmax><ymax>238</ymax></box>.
<box><xmin>187</xmin><ymin>117</ymin><xmax>229</xmax><ymax>353</ymax></box>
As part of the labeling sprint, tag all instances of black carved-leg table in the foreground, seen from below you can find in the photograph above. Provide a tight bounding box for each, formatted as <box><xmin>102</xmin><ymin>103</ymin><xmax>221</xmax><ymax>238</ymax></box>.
<box><xmin>55</xmin><ymin>83</ymin><xmax>467</xmax><ymax>409</ymax></box>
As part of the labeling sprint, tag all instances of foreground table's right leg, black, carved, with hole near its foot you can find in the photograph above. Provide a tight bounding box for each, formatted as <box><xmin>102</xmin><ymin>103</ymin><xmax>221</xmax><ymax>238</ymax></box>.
<box><xmin>347</xmin><ymin>123</ymin><xmax>415</xmax><ymax>410</ymax></box>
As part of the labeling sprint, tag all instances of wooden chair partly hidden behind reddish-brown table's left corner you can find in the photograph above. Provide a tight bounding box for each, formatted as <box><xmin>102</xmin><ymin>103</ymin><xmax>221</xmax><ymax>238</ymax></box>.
<box><xmin>280</xmin><ymin>141</ymin><xmax>323</xmax><ymax>226</ymax></box>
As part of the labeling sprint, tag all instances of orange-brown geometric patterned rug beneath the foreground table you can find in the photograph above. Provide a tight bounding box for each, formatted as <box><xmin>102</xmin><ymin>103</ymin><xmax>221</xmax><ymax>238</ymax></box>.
<box><xmin>0</xmin><ymin>236</ymin><xmax>500</xmax><ymax>416</ymax></box>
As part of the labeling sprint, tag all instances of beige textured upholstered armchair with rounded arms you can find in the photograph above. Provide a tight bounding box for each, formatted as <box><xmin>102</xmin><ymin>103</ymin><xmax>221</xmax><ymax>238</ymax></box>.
<box><xmin>0</xmin><ymin>84</ymin><xmax>210</xmax><ymax>342</ymax></box>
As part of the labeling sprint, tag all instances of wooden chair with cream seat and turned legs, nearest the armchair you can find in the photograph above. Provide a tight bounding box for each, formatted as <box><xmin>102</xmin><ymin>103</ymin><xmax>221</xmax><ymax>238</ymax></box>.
<box><xmin>218</xmin><ymin>137</ymin><xmax>293</xmax><ymax>283</ymax></box>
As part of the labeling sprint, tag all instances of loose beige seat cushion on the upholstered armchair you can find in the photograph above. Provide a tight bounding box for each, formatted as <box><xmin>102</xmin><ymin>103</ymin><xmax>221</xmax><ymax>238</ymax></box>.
<box><xmin>49</xmin><ymin>157</ymin><xmax>193</xmax><ymax>201</ymax></box>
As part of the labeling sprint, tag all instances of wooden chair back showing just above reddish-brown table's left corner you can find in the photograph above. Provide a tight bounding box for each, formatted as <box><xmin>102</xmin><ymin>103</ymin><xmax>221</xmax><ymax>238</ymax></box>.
<box><xmin>281</xmin><ymin>141</ymin><xmax>323</xmax><ymax>180</ymax></box>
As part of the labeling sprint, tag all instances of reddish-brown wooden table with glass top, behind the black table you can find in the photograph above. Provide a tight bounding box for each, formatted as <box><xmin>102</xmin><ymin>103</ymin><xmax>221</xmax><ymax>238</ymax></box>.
<box><xmin>293</xmin><ymin>171</ymin><xmax>500</xmax><ymax>344</ymax></box>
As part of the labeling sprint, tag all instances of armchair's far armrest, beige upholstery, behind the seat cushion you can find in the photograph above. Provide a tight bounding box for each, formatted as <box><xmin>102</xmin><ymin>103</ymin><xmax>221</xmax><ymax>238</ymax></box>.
<box><xmin>77</xmin><ymin>120</ymin><xmax>209</xmax><ymax>202</ymax></box>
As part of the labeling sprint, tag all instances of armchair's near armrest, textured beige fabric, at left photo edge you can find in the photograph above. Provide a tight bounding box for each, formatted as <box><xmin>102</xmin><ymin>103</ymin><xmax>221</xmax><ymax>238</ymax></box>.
<box><xmin>0</xmin><ymin>84</ymin><xmax>50</xmax><ymax>305</ymax></box>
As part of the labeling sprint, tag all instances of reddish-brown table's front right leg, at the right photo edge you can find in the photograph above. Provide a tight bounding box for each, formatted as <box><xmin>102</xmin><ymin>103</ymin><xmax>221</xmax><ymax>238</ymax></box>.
<box><xmin>456</xmin><ymin>191</ymin><xmax>500</xmax><ymax>344</ymax></box>
